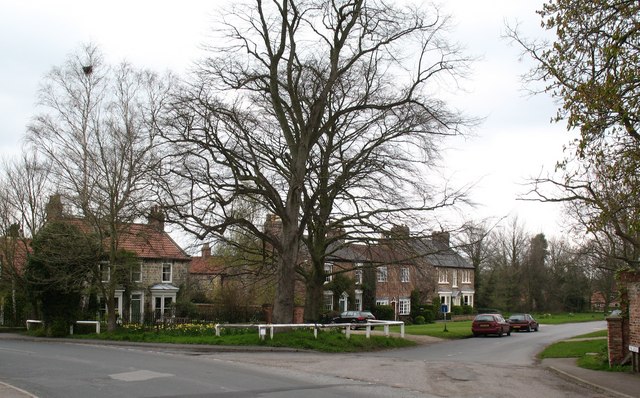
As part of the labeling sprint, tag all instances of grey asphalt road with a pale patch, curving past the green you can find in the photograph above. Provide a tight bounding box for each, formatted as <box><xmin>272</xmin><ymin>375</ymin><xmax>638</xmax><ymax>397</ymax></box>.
<box><xmin>0</xmin><ymin>322</ymin><xmax>605</xmax><ymax>398</ymax></box>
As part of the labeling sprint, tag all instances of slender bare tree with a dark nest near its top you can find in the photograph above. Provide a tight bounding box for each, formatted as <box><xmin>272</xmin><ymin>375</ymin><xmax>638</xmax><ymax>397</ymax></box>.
<box><xmin>28</xmin><ymin>45</ymin><xmax>169</xmax><ymax>329</ymax></box>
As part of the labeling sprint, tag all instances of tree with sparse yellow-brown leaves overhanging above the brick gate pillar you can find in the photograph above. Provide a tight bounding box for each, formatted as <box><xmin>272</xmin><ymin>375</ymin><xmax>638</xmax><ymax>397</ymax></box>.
<box><xmin>508</xmin><ymin>0</ymin><xmax>640</xmax><ymax>268</ymax></box>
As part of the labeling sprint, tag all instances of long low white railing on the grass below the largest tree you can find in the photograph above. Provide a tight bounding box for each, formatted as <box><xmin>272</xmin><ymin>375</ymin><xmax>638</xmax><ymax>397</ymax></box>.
<box><xmin>215</xmin><ymin>321</ymin><xmax>404</xmax><ymax>340</ymax></box>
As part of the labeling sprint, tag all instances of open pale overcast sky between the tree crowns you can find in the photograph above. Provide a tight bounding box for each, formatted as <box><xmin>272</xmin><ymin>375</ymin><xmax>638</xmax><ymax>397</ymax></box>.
<box><xmin>0</xmin><ymin>0</ymin><xmax>569</xmax><ymax>236</ymax></box>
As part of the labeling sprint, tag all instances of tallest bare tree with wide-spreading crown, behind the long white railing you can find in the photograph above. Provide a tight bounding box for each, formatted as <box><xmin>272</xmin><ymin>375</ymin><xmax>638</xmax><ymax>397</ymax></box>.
<box><xmin>158</xmin><ymin>0</ymin><xmax>467</xmax><ymax>322</ymax></box>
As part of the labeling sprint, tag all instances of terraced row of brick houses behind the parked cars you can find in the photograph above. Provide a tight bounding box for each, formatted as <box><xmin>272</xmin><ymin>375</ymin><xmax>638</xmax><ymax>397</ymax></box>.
<box><xmin>324</xmin><ymin>228</ymin><xmax>475</xmax><ymax>319</ymax></box>
